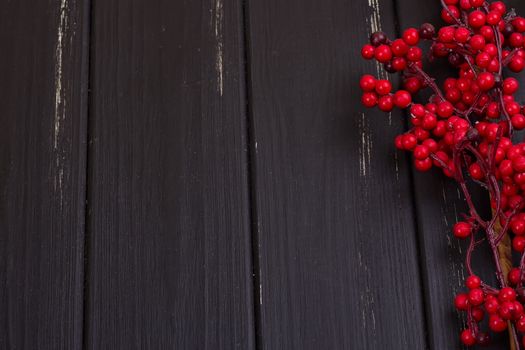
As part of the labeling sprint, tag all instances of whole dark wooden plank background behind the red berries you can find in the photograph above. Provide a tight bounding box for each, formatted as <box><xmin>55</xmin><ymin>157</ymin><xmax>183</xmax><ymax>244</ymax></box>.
<box><xmin>0</xmin><ymin>0</ymin><xmax>525</xmax><ymax>350</ymax></box>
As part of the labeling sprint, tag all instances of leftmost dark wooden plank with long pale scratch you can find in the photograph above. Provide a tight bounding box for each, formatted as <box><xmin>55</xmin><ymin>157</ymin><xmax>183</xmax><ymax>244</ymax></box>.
<box><xmin>0</xmin><ymin>0</ymin><xmax>89</xmax><ymax>349</ymax></box>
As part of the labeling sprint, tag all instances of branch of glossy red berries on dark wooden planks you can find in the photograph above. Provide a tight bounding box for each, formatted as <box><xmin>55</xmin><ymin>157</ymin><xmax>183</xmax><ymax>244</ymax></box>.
<box><xmin>360</xmin><ymin>0</ymin><xmax>525</xmax><ymax>349</ymax></box>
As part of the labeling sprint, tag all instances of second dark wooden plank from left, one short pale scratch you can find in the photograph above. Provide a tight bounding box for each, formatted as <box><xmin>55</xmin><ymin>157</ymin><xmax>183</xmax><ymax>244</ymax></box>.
<box><xmin>87</xmin><ymin>0</ymin><xmax>254</xmax><ymax>349</ymax></box>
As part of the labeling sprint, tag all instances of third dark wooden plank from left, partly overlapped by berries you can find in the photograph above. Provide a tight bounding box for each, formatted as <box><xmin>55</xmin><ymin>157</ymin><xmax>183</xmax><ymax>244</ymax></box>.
<box><xmin>249</xmin><ymin>0</ymin><xmax>426</xmax><ymax>349</ymax></box>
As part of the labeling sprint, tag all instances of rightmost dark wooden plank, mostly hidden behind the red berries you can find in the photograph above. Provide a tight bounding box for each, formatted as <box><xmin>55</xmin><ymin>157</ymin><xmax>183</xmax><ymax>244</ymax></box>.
<box><xmin>396</xmin><ymin>0</ymin><xmax>525</xmax><ymax>350</ymax></box>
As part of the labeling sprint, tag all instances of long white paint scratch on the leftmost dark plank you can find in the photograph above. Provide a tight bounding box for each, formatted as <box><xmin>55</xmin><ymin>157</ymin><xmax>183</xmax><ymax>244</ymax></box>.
<box><xmin>53</xmin><ymin>0</ymin><xmax>72</xmax><ymax>203</ymax></box>
